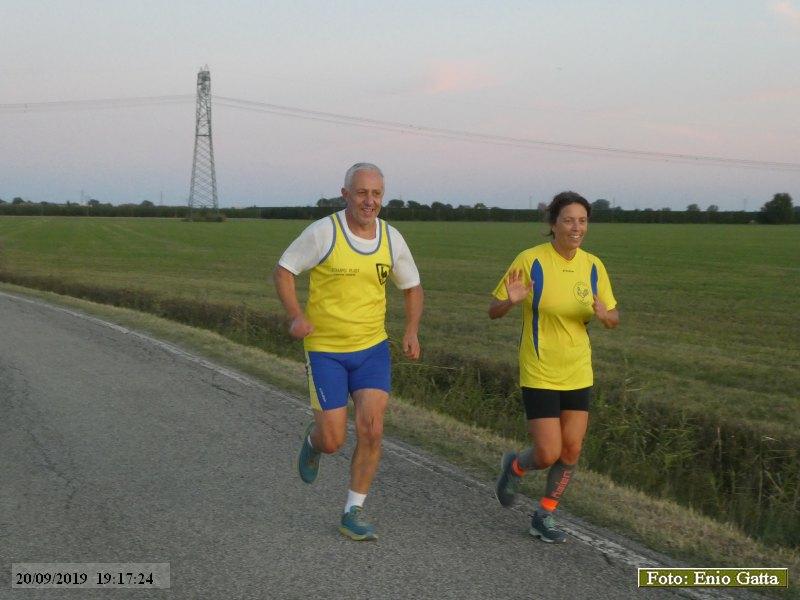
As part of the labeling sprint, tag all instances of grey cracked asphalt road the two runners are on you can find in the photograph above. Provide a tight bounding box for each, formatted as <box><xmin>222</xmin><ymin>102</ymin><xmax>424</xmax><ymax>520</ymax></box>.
<box><xmin>0</xmin><ymin>293</ymin><xmax>760</xmax><ymax>600</ymax></box>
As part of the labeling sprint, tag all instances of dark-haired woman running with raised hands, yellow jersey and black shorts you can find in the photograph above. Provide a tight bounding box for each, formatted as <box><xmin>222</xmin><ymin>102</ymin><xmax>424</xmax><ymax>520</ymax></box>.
<box><xmin>489</xmin><ymin>192</ymin><xmax>619</xmax><ymax>542</ymax></box>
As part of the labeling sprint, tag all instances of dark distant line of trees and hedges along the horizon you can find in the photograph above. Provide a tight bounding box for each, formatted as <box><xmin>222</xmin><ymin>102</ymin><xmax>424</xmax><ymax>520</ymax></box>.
<box><xmin>0</xmin><ymin>193</ymin><xmax>800</xmax><ymax>224</ymax></box>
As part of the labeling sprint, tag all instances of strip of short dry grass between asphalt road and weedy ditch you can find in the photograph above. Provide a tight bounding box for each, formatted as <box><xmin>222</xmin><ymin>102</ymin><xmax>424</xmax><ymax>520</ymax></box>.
<box><xmin>0</xmin><ymin>284</ymin><xmax>800</xmax><ymax>598</ymax></box>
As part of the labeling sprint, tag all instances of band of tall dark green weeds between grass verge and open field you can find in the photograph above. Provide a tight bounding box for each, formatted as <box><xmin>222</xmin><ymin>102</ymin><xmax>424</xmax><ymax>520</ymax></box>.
<box><xmin>0</xmin><ymin>271</ymin><xmax>800</xmax><ymax>548</ymax></box>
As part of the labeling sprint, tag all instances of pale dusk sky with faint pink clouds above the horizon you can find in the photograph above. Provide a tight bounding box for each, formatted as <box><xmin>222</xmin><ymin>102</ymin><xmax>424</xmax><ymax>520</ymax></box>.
<box><xmin>0</xmin><ymin>0</ymin><xmax>800</xmax><ymax>210</ymax></box>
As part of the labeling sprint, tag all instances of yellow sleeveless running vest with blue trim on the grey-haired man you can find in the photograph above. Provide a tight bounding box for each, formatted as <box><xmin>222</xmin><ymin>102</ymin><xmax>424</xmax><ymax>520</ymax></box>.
<box><xmin>304</xmin><ymin>213</ymin><xmax>392</xmax><ymax>352</ymax></box>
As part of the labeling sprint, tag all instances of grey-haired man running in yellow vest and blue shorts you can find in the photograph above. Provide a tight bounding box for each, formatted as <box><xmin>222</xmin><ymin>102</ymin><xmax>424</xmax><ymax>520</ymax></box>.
<box><xmin>274</xmin><ymin>163</ymin><xmax>423</xmax><ymax>541</ymax></box>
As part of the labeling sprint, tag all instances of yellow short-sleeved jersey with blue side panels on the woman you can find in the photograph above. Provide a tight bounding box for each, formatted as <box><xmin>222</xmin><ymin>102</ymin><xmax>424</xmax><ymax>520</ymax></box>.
<box><xmin>493</xmin><ymin>242</ymin><xmax>617</xmax><ymax>390</ymax></box>
